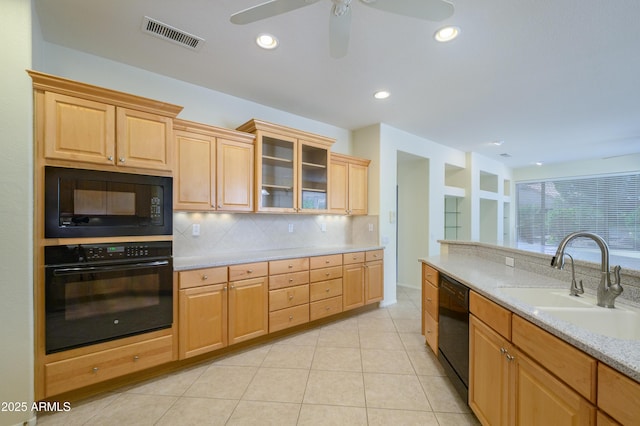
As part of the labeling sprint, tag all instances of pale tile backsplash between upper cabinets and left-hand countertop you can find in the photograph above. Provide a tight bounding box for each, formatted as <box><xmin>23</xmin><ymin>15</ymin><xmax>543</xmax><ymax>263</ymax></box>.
<box><xmin>173</xmin><ymin>212</ymin><xmax>379</xmax><ymax>257</ymax></box>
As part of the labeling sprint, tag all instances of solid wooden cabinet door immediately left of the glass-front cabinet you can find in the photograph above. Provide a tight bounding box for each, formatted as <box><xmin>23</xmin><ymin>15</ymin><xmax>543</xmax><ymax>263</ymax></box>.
<box><xmin>216</xmin><ymin>139</ymin><xmax>253</xmax><ymax>211</ymax></box>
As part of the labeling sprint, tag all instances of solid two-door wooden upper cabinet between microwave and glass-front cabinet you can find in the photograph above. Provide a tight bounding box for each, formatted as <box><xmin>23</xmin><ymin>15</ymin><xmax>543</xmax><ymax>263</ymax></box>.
<box><xmin>174</xmin><ymin>120</ymin><xmax>254</xmax><ymax>211</ymax></box>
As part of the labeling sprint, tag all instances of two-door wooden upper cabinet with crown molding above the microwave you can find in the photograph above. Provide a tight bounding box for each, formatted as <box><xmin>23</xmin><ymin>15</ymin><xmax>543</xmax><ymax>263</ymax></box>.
<box><xmin>29</xmin><ymin>71</ymin><xmax>182</xmax><ymax>174</ymax></box>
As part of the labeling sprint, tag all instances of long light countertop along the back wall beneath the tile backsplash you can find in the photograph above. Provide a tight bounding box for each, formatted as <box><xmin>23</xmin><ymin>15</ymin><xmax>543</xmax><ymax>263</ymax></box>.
<box><xmin>173</xmin><ymin>245</ymin><xmax>384</xmax><ymax>271</ymax></box>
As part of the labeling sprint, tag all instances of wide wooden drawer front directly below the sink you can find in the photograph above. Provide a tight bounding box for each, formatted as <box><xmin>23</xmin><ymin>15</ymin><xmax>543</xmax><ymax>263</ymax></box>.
<box><xmin>512</xmin><ymin>315</ymin><xmax>597</xmax><ymax>404</ymax></box>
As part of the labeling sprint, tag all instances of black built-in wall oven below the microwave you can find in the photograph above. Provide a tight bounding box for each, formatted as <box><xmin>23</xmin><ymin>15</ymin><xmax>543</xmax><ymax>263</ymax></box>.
<box><xmin>44</xmin><ymin>241</ymin><xmax>173</xmax><ymax>354</ymax></box>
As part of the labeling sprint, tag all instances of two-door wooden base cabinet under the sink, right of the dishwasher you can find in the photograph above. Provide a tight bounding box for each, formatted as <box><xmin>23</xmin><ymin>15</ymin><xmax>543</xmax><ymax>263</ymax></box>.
<box><xmin>469</xmin><ymin>292</ymin><xmax>596</xmax><ymax>425</ymax></box>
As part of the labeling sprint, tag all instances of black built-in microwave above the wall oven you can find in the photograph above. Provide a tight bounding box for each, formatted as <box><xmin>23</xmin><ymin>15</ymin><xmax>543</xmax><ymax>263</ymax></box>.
<box><xmin>44</xmin><ymin>166</ymin><xmax>173</xmax><ymax>238</ymax></box>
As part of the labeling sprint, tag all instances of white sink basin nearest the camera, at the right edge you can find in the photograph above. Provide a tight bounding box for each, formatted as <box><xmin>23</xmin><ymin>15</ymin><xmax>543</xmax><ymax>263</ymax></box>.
<box><xmin>534</xmin><ymin>306</ymin><xmax>640</xmax><ymax>340</ymax></box>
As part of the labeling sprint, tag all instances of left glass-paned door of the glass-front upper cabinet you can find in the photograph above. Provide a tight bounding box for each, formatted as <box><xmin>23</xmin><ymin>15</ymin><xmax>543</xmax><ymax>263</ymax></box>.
<box><xmin>256</xmin><ymin>132</ymin><xmax>298</xmax><ymax>213</ymax></box>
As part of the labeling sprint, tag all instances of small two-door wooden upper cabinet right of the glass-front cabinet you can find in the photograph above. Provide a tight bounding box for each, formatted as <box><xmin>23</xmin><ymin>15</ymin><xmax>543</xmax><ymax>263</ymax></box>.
<box><xmin>329</xmin><ymin>154</ymin><xmax>370</xmax><ymax>215</ymax></box>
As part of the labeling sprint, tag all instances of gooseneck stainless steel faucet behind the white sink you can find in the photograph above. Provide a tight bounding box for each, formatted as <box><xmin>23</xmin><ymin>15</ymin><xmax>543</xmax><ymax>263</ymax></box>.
<box><xmin>551</xmin><ymin>231</ymin><xmax>622</xmax><ymax>308</ymax></box>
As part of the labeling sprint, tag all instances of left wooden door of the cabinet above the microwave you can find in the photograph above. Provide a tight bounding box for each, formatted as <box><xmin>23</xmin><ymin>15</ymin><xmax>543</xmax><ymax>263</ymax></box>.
<box><xmin>44</xmin><ymin>92</ymin><xmax>116</xmax><ymax>165</ymax></box>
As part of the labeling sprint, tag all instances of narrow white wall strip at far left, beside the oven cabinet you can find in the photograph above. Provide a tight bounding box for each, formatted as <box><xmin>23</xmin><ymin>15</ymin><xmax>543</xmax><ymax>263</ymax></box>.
<box><xmin>0</xmin><ymin>0</ymin><xmax>34</xmax><ymax>425</ymax></box>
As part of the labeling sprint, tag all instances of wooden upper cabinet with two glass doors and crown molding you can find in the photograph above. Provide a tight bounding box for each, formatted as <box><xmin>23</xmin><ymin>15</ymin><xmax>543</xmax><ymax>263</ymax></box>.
<box><xmin>238</xmin><ymin>120</ymin><xmax>334</xmax><ymax>213</ymax></box>
